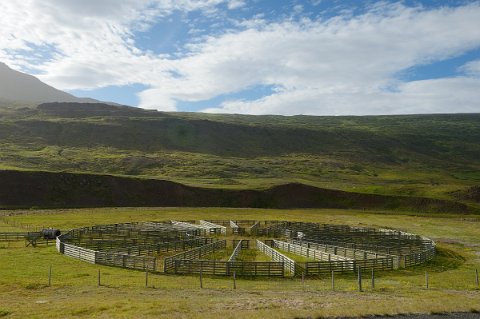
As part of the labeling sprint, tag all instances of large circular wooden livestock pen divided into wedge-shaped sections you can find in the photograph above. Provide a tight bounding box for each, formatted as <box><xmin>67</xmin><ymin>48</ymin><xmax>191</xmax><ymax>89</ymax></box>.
<box><xmin>57</xmin><ymin>220</ymin><xmax>435</xmax><ymax>277</ymax></box>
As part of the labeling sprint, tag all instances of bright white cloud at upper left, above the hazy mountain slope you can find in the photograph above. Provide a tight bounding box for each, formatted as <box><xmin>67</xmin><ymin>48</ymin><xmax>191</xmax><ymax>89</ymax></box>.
<box><xmin>0</xmin><ymin>0</ymin><xmax>224</xmax><ymax>89</ymax></box>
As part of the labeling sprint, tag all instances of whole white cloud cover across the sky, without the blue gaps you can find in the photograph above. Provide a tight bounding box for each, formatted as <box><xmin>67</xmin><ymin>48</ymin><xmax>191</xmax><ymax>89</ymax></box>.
<box><xmin>0</xmin><ymin>0</ymin><xmax>480</xmax><ymax>114</ymax></box>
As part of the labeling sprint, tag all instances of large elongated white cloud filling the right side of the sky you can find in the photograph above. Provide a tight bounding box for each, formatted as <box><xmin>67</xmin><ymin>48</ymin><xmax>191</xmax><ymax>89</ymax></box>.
<box><xmin>137</xmin><ymin>5</ymin><xmax>480</xmax><ymax>114</ymax></box>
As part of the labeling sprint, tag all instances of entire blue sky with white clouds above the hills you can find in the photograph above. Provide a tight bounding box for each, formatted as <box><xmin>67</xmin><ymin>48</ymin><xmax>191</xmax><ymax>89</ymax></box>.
<box><xmin>0</xmin><ymin>0</ymin><xmax>480</xmax><ymax>115</ymax></box>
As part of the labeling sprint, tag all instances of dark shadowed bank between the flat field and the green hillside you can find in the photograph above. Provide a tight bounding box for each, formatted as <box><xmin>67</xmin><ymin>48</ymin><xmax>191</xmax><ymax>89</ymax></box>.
<box><xmin>0</xmin><ymin>171</ymin><xmax>472</xmax><ymax>213</ymax></box>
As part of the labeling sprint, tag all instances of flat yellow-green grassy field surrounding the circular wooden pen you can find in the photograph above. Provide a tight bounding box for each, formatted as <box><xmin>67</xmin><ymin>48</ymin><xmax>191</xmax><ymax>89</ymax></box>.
<box><xmin>0</xmin><ymin>208</ymin><xmax>480</xmax><ymax>319</ymax></box>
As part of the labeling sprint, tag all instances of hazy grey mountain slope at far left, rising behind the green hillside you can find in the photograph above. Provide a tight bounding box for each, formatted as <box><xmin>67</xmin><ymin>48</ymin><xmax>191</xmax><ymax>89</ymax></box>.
<box><xmin>0</xmin><ymin>62</ymin><xmax>98</xmax><ymax>104</ymax></box>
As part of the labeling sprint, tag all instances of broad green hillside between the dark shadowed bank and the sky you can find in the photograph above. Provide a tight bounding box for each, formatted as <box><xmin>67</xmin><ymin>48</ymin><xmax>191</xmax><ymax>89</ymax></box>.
<box><xmin>0</xmin><ymin>103</ymin><xmax>480</xmax><ymax>206</ymax></box>
